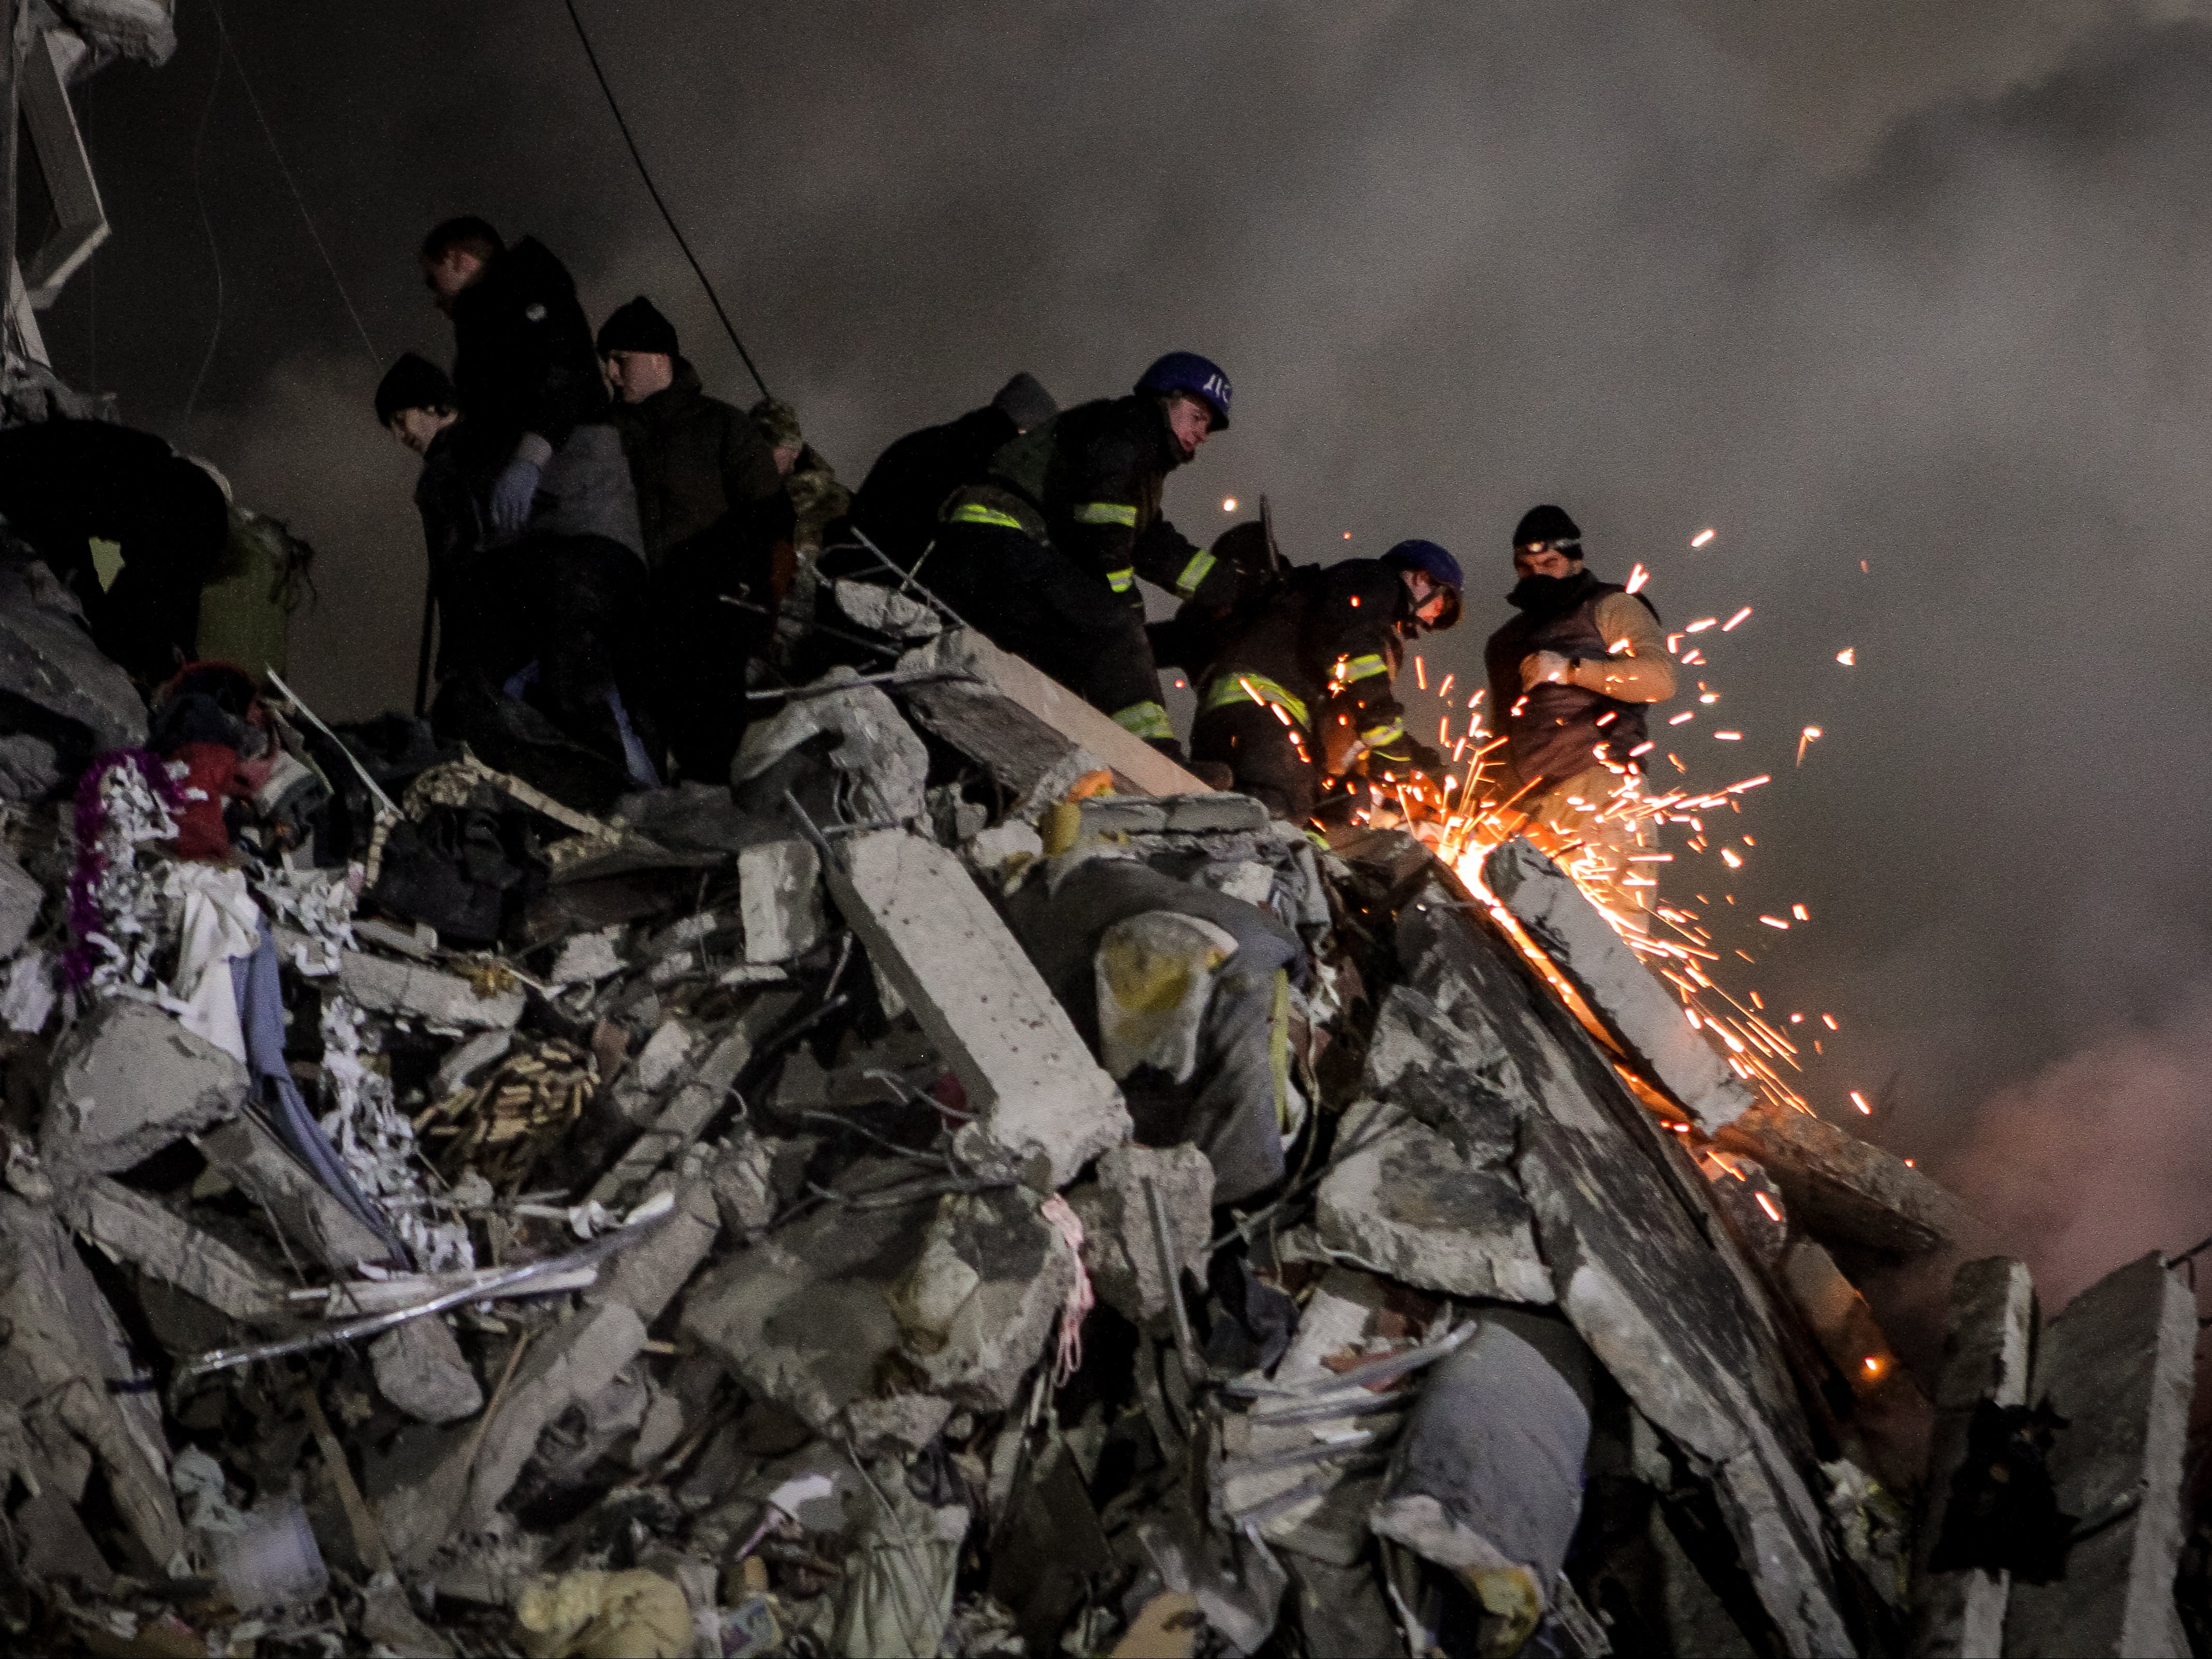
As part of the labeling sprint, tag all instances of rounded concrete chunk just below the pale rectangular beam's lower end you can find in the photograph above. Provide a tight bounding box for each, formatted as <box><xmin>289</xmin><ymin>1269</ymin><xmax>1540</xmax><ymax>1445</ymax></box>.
<box><xmin>887</xmin><ymin>1188</ymin><xmax>1077</xmax><ymax>1411</ymax></box>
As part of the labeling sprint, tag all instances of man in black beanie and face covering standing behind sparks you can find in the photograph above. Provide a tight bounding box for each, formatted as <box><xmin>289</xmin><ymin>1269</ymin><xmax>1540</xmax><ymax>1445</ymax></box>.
<box><xmin>1482</xmin><ymin>504</ymin><xmax>1674</xmax><ymax>913</ymax></box>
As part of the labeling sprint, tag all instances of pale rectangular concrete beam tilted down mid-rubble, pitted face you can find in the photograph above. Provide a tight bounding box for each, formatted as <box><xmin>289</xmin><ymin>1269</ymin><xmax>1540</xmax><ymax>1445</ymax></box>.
<box><xmin>827</xmin><ymin>832</ymin><xmax>1130</xmax><ymax>1188</ymax></box>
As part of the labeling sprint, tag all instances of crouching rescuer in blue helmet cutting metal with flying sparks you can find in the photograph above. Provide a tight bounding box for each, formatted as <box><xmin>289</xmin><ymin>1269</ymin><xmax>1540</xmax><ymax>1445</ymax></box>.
<box><xmin>1190</xmin><ymin>540</ymin><xmax>1462</xmax><ymax>827</ymax></box>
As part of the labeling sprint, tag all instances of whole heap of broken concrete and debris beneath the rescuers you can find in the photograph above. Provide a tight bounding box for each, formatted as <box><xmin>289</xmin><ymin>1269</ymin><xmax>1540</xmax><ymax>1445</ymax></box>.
<box><xmin>0</xmin><ymin>566</ymin><xmax>2192</xmax><ymax>1659</ymax></box>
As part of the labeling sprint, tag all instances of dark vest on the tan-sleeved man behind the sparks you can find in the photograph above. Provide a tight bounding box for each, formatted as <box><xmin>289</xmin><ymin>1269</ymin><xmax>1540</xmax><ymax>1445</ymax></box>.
<box><xmin>1482</xmin><ymin>571</ymin><xmax>1659</xmax><ymax>788</ymax></box>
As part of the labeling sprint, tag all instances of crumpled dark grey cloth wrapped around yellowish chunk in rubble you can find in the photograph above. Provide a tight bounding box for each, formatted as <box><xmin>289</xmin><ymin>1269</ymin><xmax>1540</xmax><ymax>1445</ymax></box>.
<box><xmin>1006</xmin><ymin>856</ymin><xmax>1305</xmax><ymax>1203</ymax></box>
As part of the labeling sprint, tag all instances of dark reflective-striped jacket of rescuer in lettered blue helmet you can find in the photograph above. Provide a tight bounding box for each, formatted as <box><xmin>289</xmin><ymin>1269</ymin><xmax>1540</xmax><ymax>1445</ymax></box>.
<box><xmin>989</xmin><ymin>396</ymin><xmax>1206</xmax><ymax>604</ymax></box>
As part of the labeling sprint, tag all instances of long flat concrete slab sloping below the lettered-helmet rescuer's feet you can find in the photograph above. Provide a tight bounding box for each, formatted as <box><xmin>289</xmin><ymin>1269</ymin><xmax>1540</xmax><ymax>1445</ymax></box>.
<box><xmin>898</xmin><ymin>628</ymin><xmax>1206</xmax><ymax>794</ymax></box>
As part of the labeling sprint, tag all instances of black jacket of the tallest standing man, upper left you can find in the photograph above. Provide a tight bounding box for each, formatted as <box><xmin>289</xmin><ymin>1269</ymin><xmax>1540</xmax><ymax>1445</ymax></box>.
<box><xmin>454</xmin><ymin>237</ymin><xmax>606</xmax><ymax>449</ymax></box>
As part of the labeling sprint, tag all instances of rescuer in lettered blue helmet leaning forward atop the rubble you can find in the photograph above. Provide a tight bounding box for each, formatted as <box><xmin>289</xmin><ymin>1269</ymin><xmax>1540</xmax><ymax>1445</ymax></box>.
<box><xmin>929</xmin><ymin>352</ymin><xmax>1230</xmax><ymax>759</ymax></box>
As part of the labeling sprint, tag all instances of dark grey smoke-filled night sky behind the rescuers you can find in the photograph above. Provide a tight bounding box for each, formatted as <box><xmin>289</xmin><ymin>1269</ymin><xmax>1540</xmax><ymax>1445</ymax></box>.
<box><xmin>47</xmin><ymin>0</ymin><xmax>2212</xmax><ymax>1290</ymax></box>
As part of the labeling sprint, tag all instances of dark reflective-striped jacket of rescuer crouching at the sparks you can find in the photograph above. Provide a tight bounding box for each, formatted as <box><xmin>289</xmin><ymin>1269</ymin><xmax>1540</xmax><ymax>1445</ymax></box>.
<box><xmin>1199</xmin><ymin>560</ymin><xmax>1413</xmax><ymax>759</ymax></box>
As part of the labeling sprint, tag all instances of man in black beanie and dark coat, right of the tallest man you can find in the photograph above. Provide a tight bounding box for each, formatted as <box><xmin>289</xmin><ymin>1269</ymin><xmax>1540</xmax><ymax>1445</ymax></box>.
<box><xmin>597</xmin><ymin>294</ymin><xmax>792</xmax><ymax>783</ymax></box>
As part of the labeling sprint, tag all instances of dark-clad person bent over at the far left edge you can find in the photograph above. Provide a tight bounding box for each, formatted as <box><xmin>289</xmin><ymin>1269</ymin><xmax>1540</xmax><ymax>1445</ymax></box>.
<box><xmin>0</xmin><ymin>420</ymin><xmax>229</xmax><ymax>690</ymax></box>
